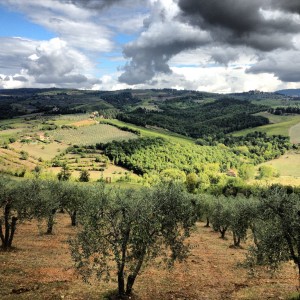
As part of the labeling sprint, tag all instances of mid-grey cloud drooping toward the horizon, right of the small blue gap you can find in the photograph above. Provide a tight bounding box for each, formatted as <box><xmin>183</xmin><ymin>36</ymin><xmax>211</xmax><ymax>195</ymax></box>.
<box><xmin>119</xmin><ymin>18</ymin><xmax>210</xmax><ymax>84</ymax></box>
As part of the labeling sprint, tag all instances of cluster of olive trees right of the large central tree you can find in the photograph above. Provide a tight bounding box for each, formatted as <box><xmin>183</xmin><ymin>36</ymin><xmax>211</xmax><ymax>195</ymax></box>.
<box><xmin>198</xmin><ymin>185</ymin><xmax>300</xmax><ymax>287</ymax></box>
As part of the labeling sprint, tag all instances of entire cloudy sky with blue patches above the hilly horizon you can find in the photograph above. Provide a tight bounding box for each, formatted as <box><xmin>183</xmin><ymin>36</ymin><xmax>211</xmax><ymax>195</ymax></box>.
<box><xmin>0</xmin><ymin>0</ymin><xmax>300</xmax><ymax>93</ymax></box>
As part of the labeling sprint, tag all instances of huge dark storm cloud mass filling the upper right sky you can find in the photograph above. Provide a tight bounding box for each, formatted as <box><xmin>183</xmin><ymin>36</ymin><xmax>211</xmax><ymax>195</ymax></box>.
<box><xmin>119</xmin><ymin>0</ymin><xmax>300</xmax><ymax>85</ymax></box>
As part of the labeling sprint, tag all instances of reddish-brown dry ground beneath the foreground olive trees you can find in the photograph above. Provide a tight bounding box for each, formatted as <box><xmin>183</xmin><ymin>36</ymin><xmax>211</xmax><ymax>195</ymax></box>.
<box><xmin>0</xmin><ymin>214</ymin><xmax>297</xmax><ymax>300</ymax></box>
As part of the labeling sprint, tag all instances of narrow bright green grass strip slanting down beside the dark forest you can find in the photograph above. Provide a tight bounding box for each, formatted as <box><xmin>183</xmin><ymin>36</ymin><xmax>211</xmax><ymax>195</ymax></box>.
<box><xmin>100</xmin><ymin>119</ymin><xmax>194</xmax><ymax>144</ymax></box>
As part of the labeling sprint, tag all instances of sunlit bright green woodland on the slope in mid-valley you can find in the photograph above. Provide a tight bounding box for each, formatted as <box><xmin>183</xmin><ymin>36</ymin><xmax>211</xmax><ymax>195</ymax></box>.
<box><xmin>96</xmin><ymin>132</ymin><xmax>291</xmax><ymax>175</ymax></box>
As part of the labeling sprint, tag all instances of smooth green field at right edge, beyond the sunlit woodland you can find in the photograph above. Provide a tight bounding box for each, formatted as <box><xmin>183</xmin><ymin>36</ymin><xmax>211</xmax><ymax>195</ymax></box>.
<box><xmin>233</xmin><ymin>112</ymin><xmax>300</xmax><ymax>136</ymax></box>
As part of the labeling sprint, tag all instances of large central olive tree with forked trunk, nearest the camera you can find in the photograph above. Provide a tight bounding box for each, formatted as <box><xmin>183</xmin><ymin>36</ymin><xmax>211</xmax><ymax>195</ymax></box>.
<box><xmin>71</xmin><ymin>182</ymin><xmax>195</xmax><ymax>298</ymax></box>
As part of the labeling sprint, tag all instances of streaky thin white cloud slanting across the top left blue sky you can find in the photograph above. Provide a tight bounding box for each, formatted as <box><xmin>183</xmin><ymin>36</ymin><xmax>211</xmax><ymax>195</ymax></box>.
<box><xmin>2</xmin><ymin>0</ymin><xmax>114</xmax><ymax>53</ymax></box>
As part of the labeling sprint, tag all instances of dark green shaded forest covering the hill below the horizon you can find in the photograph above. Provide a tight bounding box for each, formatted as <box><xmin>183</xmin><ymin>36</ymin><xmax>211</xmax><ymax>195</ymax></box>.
<box><xmin>117</xmin><ymin>98</ymin><xmax>269</xmax><ymax>138</ymax></box>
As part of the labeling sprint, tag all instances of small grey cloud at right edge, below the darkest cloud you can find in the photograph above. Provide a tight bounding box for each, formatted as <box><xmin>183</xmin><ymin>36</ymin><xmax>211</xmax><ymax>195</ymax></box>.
<box><xmin>247</xmin><ymin>50</ymin><xmax>300</xmax><ymax>82</ymax></box>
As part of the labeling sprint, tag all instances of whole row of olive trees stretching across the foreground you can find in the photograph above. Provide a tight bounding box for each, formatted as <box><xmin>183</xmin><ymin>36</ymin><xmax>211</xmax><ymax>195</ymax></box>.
<box><xmin>0</xmin><ymin>177</ymin><xmax>300</xmax><ymax>296</ymax></box>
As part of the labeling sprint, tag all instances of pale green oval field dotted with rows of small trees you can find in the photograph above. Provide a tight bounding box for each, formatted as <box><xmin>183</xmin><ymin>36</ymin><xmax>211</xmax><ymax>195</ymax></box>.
<box><xmin>49</xmin><ymin>124</ymin><xmax>137</xmax><ymax>145</ymax></box>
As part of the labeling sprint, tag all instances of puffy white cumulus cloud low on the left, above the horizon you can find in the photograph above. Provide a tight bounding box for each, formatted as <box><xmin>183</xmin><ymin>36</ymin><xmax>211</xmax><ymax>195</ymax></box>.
<box><xmin>0</xmin><ymin>38</ymin><xmax>99</xmax><ymax>88</ymax></box>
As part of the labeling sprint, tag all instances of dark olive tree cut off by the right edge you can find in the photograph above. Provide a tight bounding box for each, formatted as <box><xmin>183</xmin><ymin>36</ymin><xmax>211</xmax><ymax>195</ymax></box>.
<box><xmin>249</xmin><ymin>186</ymin><xmax>300</xmax><ymax>287</ymax></box>
